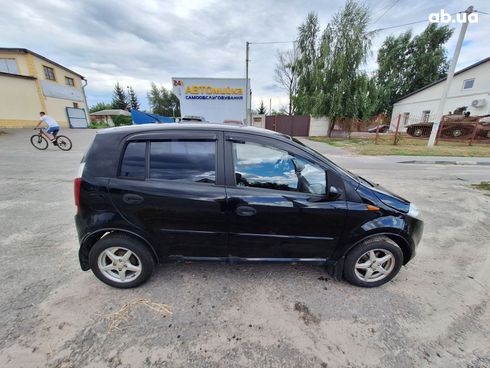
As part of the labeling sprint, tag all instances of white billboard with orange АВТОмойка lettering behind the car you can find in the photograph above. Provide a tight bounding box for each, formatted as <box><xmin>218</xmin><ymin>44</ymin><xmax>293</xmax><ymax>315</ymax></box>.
<box><xmin>172</xmin><ymin>77</ymin><xmax>247</xmax><ymax>123</ymax></box>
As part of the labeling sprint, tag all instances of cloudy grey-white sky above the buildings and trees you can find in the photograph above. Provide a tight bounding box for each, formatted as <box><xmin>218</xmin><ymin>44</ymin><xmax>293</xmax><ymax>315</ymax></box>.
<box><xmin>0</xmin><ymin>0</ymin><xmax>490</xmax><ymax>109</ymax></box>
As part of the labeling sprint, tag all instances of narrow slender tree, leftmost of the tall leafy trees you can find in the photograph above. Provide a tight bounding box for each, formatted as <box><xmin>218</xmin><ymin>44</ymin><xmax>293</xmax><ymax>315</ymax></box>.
<box><xmin>293</xmin><ymin>13</ymin><xmax>320</xmax><ymax>115</ymax></box>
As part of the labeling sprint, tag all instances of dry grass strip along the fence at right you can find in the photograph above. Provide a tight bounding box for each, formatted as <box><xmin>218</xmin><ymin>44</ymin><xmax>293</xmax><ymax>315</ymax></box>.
<box><xmin>309</xmin><ymin>136</ymin><xmax>490</xmax><ymax>157</ymax></box>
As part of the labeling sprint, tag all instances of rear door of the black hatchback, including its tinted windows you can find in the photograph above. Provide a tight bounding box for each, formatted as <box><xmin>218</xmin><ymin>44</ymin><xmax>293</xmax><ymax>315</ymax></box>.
<box><xmin>109</xmin><ymin>131</ymin><xmax>228</xmax><ymax>257</ymax></box>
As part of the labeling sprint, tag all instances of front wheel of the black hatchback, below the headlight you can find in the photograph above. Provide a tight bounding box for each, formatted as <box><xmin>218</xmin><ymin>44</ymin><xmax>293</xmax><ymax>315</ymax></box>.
<box><xmin>344</xmin><ymin>236</ymin><xmax>403</xmax><ymax>287</ymax></box>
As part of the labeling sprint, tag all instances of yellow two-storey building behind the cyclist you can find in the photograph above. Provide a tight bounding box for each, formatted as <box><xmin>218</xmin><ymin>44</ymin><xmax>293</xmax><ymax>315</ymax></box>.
<box><xmin>0</xmin><ymin>47</ymin><xmax>88</xmax><ymax>128</ymax></box>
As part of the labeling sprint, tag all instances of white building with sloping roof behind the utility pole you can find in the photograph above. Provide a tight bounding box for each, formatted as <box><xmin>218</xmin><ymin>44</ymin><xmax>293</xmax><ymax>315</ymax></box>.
<box><xmin>391</xmin><ymin>57</ymin><xmax>490</xmax><ymax>131</ymax></box>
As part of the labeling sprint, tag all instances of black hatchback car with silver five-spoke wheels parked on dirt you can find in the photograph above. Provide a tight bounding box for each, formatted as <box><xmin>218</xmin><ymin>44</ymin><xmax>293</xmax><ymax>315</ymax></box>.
<box><xmin>75</xmin><ymin>124</ymin><xmax>423</xmax><ymax>288</ymax></box>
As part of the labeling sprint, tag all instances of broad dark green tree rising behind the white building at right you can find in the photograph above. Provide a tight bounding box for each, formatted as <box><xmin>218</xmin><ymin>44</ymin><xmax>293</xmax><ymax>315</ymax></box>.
<box><xmin>376</xmin><ymin>23</ymin><xmax>453</xmax><ymax>113</ymax></box>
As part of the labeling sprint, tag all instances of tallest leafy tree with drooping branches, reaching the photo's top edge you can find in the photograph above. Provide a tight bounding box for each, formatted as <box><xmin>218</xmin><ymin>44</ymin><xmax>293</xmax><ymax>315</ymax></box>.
<box><xmin>313</xmin><ymin>0</ymin><xmax>372</xmax><ymax>136</ymax></box>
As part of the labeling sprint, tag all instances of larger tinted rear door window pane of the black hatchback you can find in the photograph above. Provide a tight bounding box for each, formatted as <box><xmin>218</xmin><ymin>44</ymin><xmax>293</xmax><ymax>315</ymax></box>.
<box><xmin>150</xmin><ymin>140</ymin><xmax>216</xmax><ymax>183</ymax></box>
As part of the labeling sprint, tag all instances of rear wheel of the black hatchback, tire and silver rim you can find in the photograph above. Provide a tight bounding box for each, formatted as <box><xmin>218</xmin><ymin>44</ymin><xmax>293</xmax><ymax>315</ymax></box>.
<box><xmin>89</xmin><ymin>234</ymin><xmax>155</xmax><ymax>289</ymax></box>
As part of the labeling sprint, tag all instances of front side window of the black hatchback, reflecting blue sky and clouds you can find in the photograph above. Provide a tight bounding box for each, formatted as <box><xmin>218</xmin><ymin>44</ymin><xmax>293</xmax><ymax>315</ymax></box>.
<box><xmin>233</xmin><ymin>142</ymin><xmax>326</xmax><ymax>195</ymax></box>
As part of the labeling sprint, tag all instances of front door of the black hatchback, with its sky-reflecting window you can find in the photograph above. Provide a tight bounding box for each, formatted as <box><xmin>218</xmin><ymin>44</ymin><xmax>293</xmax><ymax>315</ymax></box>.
<box><xmin>225</xmin><ymin>133</ymin><xmax>347</xmax><ymax>259</ymax></box>
